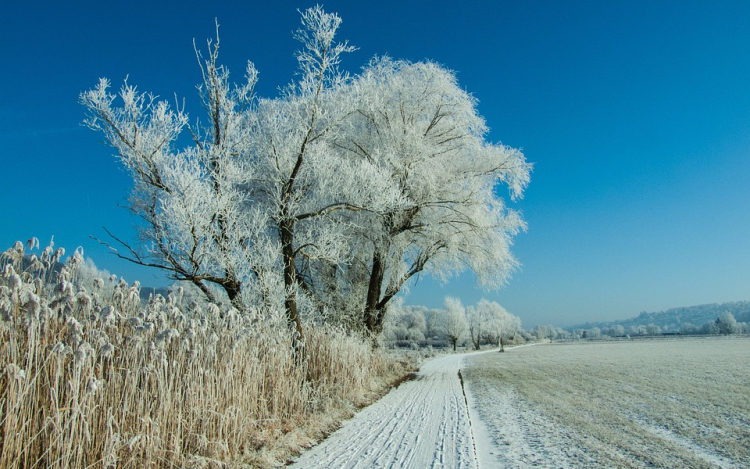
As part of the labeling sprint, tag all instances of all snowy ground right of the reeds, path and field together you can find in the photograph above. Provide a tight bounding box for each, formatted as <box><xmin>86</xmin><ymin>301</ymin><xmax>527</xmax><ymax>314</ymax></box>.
<box><xmin>292</xmin><ymin>338</ymin><xmax>750</xmax><ymax>469</ymax></box>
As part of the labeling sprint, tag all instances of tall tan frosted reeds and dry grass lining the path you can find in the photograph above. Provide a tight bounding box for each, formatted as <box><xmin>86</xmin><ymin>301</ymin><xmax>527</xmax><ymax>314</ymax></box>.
<box><xmin>0</xmin><ymin>243</ymin><xmax>406</xmax><ymax>469</ymax></box>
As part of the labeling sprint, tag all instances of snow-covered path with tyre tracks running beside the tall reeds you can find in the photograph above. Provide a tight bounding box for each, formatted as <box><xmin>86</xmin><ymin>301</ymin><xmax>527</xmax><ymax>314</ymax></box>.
<box><xmin>291</xmin><ymin>354</ymin><xmax>478</xmax><ymax>469</ymax></box>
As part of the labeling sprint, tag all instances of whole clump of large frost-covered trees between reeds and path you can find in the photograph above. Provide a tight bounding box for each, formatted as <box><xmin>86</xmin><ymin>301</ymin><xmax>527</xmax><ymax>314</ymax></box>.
<box><xmin>81</xmin><ymin>7</ymin><xmax>530</xmax><ymax>343</ymax></box>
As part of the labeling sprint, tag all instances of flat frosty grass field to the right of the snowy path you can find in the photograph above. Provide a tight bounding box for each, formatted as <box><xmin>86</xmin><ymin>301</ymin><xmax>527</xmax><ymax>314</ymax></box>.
<box><xmin>462</xmin><ymin>338</ymin><xmax>750</xmax><ymax>468</ymax></box>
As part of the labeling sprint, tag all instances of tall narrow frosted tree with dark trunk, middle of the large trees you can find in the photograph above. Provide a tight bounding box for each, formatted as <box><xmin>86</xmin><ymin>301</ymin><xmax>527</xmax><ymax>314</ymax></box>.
<box><xmin>246</xmin><ymin>7</ymin><xmax>362</xmax><ymax>336</ymax></box>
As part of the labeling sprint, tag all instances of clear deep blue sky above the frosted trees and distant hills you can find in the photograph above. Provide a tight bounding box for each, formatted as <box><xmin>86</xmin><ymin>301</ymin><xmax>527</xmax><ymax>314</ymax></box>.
<box><xmin>0</xmin><ymin>0</ymin><xmax>750</xmax><ymax>327</ymax></box>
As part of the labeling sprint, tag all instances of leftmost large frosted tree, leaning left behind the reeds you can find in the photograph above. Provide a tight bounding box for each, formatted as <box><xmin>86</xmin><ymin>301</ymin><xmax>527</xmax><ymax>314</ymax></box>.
<box><xmin>80</xmin><ymin>30</ymin><xmax>266</xmax><ymax>308</ymax></box>
